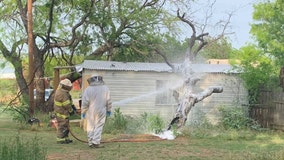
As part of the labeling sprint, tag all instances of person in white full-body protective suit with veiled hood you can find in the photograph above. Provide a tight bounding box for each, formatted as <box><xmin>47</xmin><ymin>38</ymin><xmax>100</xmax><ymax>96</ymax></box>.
<box><xmin>81</xmin><ymin>75</ymin><xmax>112</xmax><ymax>148</ymax></box>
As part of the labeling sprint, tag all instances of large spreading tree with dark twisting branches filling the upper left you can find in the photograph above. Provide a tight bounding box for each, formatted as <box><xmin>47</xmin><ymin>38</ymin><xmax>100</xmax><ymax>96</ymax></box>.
<box><xmin>0</xmin><ymin>0</ymin><xmax>172</xmax><ymax>110</ymax></box>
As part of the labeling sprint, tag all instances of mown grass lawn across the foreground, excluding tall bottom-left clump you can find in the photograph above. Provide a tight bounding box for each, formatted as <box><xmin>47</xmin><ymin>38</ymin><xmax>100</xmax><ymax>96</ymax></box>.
<box><xmin>0</xmin><ymin>107</ymin><xmax>284</xmax><ymax>160</ymax></box>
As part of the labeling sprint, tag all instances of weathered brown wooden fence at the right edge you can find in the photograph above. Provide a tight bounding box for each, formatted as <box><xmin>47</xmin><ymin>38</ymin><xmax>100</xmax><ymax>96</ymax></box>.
<box><xmin>250</xmin><ymin>90</ymin><xmax>284</xmax><ymax>130</ymax></box>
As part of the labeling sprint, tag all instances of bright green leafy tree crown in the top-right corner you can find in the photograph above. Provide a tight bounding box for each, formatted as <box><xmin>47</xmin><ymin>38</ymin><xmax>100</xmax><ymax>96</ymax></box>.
<box><xmin>250</xmin><ymin>0</ymin><xmax>284</xmax><ymax>66</ymax></box>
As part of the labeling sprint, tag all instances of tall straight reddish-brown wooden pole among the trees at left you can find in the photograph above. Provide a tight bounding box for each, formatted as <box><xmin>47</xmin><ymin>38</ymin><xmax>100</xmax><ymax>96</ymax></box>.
<box><xmin>27</xmin><ymin>0</ymin><xmax>34</xmax><ymax>117</ymax></box>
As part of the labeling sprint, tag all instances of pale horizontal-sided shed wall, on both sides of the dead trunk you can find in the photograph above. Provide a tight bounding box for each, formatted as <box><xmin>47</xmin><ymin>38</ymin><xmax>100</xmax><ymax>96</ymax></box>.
<box><xmin>82</xmin><ymin>69</ymin><xmax>247</xmax><ymax>123</ymax></box>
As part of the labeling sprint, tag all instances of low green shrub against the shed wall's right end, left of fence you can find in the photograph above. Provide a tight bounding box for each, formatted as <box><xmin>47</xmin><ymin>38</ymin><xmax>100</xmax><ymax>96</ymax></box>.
<box><xmin>219</xmin><ymin>106</ymin><xmax>258</xmax><ymax>129</ymax></box>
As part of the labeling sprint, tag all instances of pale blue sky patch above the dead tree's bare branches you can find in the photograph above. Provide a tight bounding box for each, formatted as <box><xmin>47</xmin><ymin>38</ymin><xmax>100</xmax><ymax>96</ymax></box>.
<box><xmin>173</xmin><ymin>0</ymin><xmax>261</xmax><ymax>49</ymax></box>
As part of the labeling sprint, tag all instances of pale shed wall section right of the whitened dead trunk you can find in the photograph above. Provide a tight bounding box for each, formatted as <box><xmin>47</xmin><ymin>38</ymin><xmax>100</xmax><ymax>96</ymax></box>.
<box><xmin>189</xmin><ymin>73</ymin><xmax>248</xmax><ymax>124</ymax></box>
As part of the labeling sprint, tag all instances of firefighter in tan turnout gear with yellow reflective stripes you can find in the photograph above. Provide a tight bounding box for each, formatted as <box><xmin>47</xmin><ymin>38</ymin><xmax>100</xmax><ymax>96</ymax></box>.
<box><xmin>54</xmin><ymin>79</ymin><xmax>75</xmax><ymax>144</ymax></box>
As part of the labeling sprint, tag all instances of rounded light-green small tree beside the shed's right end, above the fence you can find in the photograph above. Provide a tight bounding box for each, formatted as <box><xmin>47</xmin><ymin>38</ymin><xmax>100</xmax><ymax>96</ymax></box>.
<box><xmin>231</xmin><ymin>45</ymin><xmax>279</xmax><ymax>104</ymax></box>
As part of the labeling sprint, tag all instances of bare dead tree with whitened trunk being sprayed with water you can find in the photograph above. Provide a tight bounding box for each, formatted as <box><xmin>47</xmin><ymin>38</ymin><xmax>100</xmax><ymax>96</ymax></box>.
<box><xmin>154</xmin><ymin>1</ymin><xmax>231</xmax><ymax>130</ymax></box>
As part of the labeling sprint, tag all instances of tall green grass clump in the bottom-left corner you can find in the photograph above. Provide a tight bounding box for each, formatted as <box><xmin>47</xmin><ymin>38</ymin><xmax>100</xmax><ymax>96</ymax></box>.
<box><xmin>0</xmin><ymin>135</ymin><xmax>47</xmax><ymax>160</ymax></box>
